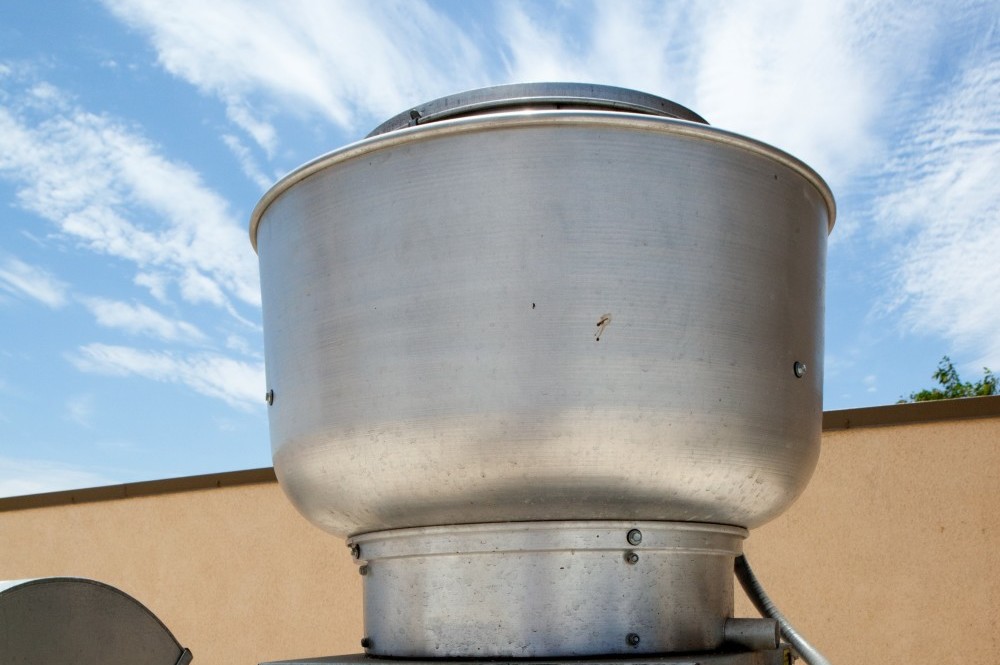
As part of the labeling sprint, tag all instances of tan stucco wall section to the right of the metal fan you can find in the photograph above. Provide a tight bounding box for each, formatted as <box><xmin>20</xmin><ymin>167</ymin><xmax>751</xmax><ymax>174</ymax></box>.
<box><xmin>742</xmin><ymin>418</ymin><xmax>1000</xmax><ymax>665</ymax></box>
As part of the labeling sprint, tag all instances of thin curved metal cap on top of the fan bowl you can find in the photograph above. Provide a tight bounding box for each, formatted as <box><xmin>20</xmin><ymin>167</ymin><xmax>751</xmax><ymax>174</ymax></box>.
<box><xmin>366</xmin><ymin>83</ymin><xmax>708</xmax><ymax>138</ymax></box>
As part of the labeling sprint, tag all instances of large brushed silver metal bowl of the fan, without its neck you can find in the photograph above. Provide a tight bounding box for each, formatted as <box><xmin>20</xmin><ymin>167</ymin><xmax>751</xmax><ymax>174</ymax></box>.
<box><xmin>251</xmin><ymin>111</ymin><xmax>834</xmax><ymax>535</ymax></box>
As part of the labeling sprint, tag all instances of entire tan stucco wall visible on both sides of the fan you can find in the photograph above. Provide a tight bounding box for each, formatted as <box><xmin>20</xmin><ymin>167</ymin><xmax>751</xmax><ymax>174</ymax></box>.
<box><xmin>0</xmin><ymin>402</ymin><xmax>1000</xmax><ymax>665</ymax></box>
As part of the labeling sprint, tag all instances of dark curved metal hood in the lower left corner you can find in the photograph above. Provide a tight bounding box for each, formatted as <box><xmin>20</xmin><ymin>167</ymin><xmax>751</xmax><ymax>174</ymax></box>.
<box><xmin>0</xmin><ymin>577</ymin><xmax>192</xmax><ymax>665</ymax></box>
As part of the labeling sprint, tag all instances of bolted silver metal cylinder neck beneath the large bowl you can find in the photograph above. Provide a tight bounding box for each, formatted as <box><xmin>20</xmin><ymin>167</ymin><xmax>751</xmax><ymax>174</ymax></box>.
<box><xmin>349</xmin><ymin>522</ymin><xmax>748</xmax><ymax>658</ymax></box>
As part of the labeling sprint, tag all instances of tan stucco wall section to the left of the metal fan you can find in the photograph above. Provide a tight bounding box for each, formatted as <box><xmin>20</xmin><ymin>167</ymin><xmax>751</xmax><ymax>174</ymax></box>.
<box><xmin>0</xmin><ymin>483</ymin><xmax>362</xmax><ymax>665</ymax></box>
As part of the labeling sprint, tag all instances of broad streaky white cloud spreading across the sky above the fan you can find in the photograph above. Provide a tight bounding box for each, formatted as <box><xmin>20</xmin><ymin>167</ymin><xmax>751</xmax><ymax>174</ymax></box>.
<box><xmin>99</xmin><ymin>0</ymin><xmax>957</xmax><ymax>193</ymax></box>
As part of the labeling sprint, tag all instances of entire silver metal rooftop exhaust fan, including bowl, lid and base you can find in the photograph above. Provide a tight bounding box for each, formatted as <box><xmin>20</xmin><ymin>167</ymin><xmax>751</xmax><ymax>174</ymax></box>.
<box><xmin>250</xmin><ymin>83</ymin><xmax>835</xmax><ymax>665</ymax></box>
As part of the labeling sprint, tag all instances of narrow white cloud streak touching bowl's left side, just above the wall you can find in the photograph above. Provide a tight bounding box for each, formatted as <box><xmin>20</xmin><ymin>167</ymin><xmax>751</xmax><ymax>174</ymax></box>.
<box><xmin>70</xmin><ymin>344</ymin><xmax>264</xmax><ymax>410</ymax></box>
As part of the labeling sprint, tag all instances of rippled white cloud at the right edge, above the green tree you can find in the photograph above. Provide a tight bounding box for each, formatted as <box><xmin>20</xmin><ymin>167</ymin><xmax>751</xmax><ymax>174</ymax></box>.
<box><xmin>874</xmin><ymin>47</ymin><xmax>1000</xmax><ymax>368</ymax></box>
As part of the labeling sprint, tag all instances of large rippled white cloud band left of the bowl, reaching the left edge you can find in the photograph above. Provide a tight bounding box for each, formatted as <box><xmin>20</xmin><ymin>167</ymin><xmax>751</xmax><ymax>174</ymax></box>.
<box><xmin>0</xmin><ymin>87</ymin><xmax>260</xmax><ymax>309</ymax></box>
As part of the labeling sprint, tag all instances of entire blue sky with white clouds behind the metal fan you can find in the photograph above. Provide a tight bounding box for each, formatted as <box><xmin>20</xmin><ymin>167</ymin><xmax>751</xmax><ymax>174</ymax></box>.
<box><xmin>0</xmin><ymin>0</ymin><xmax>1000</xmax><ymax>496</ymax></box>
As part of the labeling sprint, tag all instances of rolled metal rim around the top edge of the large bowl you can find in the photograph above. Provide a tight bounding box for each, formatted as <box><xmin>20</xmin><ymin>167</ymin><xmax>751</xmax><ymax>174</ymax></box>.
<box><xmin>250</xmin><ymin>110</ymin><xmax>837</xmax><ymax>251</ymax></box>
